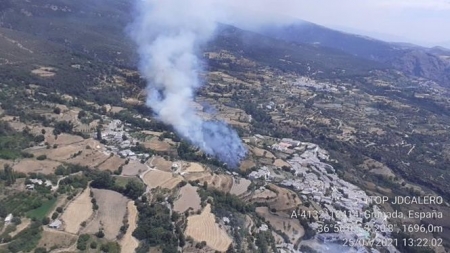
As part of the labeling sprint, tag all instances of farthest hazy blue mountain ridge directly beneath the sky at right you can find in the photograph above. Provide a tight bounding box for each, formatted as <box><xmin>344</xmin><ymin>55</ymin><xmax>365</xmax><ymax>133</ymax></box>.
<box><xmin>259</xmin><ymin>22</ymin><xmax>450</xmax><ymax>84</ymax></box>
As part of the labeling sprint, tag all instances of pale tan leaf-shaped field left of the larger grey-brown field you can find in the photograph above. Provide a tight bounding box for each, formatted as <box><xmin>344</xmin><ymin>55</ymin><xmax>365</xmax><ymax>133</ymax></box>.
<box><xmin>61</xmin><ymin>188</ymin><xmax>93</xmax><ymax>234</ymax></box>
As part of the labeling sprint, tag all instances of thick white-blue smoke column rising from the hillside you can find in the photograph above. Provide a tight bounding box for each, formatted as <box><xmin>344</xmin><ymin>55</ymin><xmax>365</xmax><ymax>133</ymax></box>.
<box><xmin>129</xmin><ymin>0</ymin><xmax>246</xmax><ymax>168</ymax></box>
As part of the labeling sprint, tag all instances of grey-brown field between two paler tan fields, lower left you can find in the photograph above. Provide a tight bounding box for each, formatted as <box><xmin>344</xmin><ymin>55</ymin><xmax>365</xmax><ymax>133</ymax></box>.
<box><xmin>83</xmin><ymin>189</ymin><xmax>129</xmax><ymax>240</ymax></box>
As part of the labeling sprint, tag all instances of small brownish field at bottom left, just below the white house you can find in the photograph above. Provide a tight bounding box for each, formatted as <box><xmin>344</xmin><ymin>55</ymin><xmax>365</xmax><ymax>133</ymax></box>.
<box><xmin>38</xmin><ymin>228</ymin><xmax>77</xmax><ymax>249</ymax></box>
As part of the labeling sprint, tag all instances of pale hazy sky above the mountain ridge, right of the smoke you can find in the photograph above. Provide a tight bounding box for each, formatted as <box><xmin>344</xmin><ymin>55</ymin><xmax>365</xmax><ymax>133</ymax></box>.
<box><xmin>227</xmin><ymin>0</ymin><xmax>450</xmax><ymax>47</ymax></box>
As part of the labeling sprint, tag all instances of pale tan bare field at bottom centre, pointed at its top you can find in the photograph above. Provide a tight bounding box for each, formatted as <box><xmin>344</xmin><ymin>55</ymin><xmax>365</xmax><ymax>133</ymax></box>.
<box><xmin>185</xmin><ymin>204</ymin><xmax>232</xmax><ymax>252</ymax></box>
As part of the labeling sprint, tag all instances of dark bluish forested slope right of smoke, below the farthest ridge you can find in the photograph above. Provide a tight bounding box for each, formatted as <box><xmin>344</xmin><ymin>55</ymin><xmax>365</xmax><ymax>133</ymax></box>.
<box><xmin>209</xmin><ymin>25</ymin><xmax>388</xmax><ymax>75</ymax></box>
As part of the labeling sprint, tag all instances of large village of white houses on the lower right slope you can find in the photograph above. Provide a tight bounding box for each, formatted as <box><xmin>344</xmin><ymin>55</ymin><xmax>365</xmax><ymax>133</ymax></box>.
<box><xmin>280</xmin><ymin>143</ymin><xmax>397</xmax><ymax>252</ymax></box>
